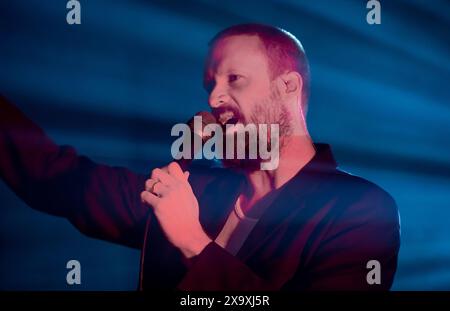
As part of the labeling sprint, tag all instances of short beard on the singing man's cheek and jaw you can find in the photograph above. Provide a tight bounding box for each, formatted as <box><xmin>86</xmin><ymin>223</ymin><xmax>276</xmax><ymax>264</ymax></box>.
<box><xmin>222</xmin><ymin>86</ymin><xmax>292</xmax><ymax>171</ymax></box>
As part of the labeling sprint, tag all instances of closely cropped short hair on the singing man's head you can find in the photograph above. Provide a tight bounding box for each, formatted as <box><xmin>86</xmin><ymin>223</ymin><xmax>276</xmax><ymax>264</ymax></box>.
<box><xmin>209</xmin><ymin>24</ymin><xmax>310</xmax><ymax>114</ymax></box>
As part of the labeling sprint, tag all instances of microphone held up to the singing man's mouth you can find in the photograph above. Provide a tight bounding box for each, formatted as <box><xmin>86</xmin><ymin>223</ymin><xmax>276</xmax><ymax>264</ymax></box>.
<box><xmin>175</xmin><ymin>111</ymin><xmax>217</xmax><ymax>171</ymax></box>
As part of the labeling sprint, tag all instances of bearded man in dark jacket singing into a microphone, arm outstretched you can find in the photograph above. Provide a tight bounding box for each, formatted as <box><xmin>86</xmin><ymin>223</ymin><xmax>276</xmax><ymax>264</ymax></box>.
<box><xmin>0</xmin><ymin>24</ymin><xmax>400</xmax><ymax>290</ymax></box>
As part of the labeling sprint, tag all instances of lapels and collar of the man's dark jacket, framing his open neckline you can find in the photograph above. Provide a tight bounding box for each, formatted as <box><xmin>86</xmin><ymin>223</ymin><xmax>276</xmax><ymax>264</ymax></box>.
<box><xmin>200</xmin><ymin>143</ymin><xmax>337</xmax><ymax>259</ymax></box>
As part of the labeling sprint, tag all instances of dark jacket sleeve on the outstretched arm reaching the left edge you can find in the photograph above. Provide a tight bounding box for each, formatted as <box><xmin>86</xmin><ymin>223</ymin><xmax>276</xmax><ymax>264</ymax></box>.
<box><xmin>0</xmin><ymin>96</ymin><xmax>149</xmax><ymax>248</ymax></box>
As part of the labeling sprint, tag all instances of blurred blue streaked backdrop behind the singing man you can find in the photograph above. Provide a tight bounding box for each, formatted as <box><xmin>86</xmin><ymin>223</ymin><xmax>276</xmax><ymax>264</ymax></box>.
<box><xmin>0</xmin><ymin>0</ymin><xmax>450</xmax><ymax>290</ymax></box>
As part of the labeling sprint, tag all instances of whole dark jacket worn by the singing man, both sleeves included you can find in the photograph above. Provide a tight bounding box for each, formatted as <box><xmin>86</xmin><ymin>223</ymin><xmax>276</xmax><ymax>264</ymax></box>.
<box><xmin>0</xmin><ymin>97</ymin><xmax>400</xmax><ymax>290</ymax></box>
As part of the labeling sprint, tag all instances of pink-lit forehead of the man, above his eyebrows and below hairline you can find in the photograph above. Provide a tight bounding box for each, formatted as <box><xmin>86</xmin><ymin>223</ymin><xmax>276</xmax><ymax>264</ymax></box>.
<box><xmin>206</xmin><ymin>35</ymin><xmax>268</xmax><ymax>75</ymax></box>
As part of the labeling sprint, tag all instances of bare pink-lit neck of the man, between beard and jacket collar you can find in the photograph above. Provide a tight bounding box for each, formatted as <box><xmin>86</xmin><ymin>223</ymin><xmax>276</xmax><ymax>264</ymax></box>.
<box><xmin>241</xmin><ymin>135</ymin><xmax>316</xmax><ymax>216</ymax></box>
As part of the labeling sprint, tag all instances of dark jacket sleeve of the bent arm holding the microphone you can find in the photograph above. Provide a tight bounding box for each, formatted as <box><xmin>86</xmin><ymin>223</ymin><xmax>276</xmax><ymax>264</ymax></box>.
<box><xmin>178</xmin><ymin>186</ymin><xmax>400</xmax><ymax>291</ymax></box>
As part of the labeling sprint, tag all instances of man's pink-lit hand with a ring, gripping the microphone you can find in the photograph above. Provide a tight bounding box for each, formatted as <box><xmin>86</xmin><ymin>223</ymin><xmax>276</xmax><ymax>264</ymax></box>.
<box><xmin>141</xmin><ymin>162</ymin><xmax>211</xmax><ymax>258</ymax></box>
